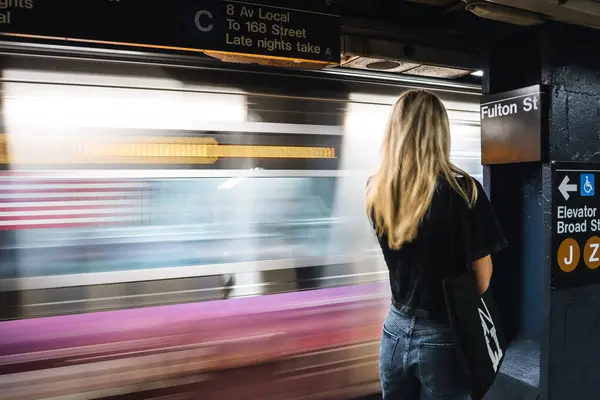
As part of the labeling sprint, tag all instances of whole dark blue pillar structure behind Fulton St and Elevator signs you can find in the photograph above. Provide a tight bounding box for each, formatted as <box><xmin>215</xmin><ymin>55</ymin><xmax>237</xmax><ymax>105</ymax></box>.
<box><xmin>484</xmin><ymin>23</ymin><xmax>600</xmax><ymax>400</ymax></box>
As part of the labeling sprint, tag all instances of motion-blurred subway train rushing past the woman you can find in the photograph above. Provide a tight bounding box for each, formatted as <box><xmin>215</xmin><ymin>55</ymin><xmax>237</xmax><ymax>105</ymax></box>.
<box><xmin>0</xmin><ymin>56</ymin><xmax>482</xmax><ymax>399</ymax></box>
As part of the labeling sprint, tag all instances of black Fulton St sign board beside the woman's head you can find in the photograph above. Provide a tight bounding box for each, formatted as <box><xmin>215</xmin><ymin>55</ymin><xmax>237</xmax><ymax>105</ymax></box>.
<box><xmin>480</xmin><ymin>85</ymin><xmax>545</xmax><ymax>164</ymax></box>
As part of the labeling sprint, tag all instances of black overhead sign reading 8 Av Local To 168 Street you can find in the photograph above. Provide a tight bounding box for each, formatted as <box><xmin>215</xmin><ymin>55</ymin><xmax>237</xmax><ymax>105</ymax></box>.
<box><xmin>0</xmin><ymin>0</ymin><xmax>340</xmax><ymax>63</ymax></box>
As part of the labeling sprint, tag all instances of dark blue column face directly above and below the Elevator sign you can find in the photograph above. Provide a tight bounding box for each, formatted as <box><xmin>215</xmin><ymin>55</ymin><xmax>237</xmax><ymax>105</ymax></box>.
<box><xmin>542</xmin><ymin>21</ymin><xmax>600</xmax><ymax>400</ymax></box>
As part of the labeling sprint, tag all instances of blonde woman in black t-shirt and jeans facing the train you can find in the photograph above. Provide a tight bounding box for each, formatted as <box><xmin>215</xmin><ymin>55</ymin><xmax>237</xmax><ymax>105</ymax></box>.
<box><xmin>366</xmin><ymin>90</ymin><xmax>507</xmax><ymax>400</ymax></box>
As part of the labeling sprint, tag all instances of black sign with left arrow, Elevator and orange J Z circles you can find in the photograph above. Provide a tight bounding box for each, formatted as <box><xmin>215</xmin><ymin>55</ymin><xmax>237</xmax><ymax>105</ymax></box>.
<box><xmin>552</xmin><ymin>163</ymin><xmax>600</xmax><ymax>289</ymax></box>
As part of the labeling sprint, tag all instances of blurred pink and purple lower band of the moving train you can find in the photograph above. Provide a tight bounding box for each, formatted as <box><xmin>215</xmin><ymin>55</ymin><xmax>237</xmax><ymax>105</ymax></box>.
<box><xmin>0</xmin><ymin>284</ymin><xmax>388</xmax><ymax>399</ymax></box>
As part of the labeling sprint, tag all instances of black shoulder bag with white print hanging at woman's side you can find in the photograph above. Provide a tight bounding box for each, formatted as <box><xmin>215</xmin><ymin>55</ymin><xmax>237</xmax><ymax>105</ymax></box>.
<box><xmin>443</xmin><ymin>205</ymin><xmax>506</xmax><ymax>400</ymax></box>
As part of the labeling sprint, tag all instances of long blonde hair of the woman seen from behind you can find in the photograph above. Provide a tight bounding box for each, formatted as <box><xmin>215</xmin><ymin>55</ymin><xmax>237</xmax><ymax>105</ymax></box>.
<box><xmin>366</xmin><ymin>90</ymin><xmax>477</xmax><ymax>249</ymax></box>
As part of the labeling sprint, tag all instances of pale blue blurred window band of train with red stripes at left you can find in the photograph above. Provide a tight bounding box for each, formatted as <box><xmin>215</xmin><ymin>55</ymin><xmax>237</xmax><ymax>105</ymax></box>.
<box><xmin>0</xmin><ymin>177</ymin><xmax>338</xmax><ymax>277</ymax></box>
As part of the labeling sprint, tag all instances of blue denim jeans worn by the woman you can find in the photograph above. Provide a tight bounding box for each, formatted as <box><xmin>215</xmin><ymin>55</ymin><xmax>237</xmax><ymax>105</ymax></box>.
<box><xmin>379</xmin><ymin>306</ymin><xmax>471</xmax><ymax>400</ymax></box>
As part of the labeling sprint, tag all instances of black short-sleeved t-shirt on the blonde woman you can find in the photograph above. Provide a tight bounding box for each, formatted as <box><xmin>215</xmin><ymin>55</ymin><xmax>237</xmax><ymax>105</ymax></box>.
<box><xmin>379</xmin><ymin>178</ymin><xmax>508</xmax><ymax>315</ymax></box>
